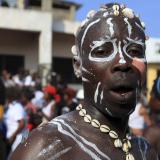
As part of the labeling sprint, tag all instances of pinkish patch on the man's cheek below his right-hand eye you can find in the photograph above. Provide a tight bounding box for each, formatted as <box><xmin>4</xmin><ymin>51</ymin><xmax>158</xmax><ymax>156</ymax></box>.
<box><xmin>132</xmin><ymin>58</ymin><xmax>146</xmax><ymax>84</ymax></box>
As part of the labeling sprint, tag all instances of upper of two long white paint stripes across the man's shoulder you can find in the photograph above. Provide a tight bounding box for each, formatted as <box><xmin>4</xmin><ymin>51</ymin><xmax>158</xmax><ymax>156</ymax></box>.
<box><xmin>55</xmin><ymin>119</ymin><xmax>110</xmax><ymax>160</ymax></box>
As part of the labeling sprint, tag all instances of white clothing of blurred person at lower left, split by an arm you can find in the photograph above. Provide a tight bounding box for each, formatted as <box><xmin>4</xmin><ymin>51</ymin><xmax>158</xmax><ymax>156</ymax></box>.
<box><xmin>4</xmin><ymin>101</ymin><xmax>27</xmax><ymax>151</ymax></box>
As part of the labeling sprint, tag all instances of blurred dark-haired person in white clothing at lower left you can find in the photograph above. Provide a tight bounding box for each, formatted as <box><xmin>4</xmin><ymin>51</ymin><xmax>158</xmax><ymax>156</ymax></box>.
<box><xmin>4</xmin><ymin>87</ymin><xmax>27</xmax><ymax>152</ymax></box>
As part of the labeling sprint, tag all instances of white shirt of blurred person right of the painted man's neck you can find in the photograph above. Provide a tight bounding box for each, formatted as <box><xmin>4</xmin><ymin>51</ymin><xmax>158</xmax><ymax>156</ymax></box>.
<box><xmin>128</xmin><ymin>103</ymin><xmax>145</xmax><ymax>129</ymax></box>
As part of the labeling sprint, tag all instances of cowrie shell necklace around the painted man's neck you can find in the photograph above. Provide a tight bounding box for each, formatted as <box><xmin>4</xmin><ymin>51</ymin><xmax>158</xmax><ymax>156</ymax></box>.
<box><xmin>76</xmin><ymin>104</ymin><xmax>135</xmax><ymax>160</ymax></box>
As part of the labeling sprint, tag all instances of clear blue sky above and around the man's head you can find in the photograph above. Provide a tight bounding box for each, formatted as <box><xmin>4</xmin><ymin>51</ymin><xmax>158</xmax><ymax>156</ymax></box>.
<box><xmin>70</xmin><ymin>0</ymin><xmax>160</xmax><ymax>38</ymax></box>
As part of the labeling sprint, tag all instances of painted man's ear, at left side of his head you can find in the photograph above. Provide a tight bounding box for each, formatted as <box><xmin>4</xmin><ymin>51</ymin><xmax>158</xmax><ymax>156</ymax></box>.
<box><xmin>73</xmin><ymin>56</ymin><xmax>82</xmax><ymax>78</ymax></box>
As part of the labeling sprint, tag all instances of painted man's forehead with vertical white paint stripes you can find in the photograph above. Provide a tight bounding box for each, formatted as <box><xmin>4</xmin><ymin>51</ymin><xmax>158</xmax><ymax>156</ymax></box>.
<box><xmin>84</xmin><ymin>17</ymin><xmax>145</xmax><ymax>41</ymax></box>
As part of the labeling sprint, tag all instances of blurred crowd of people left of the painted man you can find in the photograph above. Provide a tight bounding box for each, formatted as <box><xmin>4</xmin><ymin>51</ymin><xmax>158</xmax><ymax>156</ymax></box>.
<box><xmin>0</xmin><ymin>69</ymin><xmax>83</xmax><ymax>160</ymax></box>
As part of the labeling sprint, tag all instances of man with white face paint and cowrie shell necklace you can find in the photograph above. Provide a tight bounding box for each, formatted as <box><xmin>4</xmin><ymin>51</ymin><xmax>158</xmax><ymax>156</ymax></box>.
<box><xmin>10</xmin><ymin>3</ymin><xmax>158</xmax><ymax>160</ymax></box>
